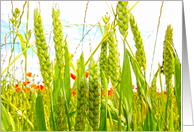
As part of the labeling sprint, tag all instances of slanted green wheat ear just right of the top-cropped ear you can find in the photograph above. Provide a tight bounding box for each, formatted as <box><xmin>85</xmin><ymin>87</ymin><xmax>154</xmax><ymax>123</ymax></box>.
<box><xmin>129</xmin><ymin>12</ymin><xmax>147</xmax><ymax>72</ymax></box>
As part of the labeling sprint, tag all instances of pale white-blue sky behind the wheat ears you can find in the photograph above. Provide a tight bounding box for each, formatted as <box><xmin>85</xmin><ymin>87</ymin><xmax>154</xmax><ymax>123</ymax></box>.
<box><xmin>1</xmin><ymin>1</ymin><xmax>182</xmax><ymax>89</ymax></box>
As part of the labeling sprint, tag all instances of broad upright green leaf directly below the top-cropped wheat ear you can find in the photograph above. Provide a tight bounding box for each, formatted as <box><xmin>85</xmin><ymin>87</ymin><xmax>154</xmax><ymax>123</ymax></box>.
<box><xmin>120</xmin><ymin>49</ymin><xmax>133</xmax><ymax>131</ymax></box>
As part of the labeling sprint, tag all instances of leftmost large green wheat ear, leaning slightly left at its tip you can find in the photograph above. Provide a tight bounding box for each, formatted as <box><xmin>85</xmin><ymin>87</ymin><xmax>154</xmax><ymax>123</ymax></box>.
<box><xmin>34</xmin><ymin>9</ymin><xmax>52</xmax><ymax>88</ymax></box>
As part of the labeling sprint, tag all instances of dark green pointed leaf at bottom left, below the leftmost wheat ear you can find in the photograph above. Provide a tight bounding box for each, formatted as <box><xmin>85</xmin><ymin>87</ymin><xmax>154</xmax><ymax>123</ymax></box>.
<box><xmin>36</xmin><ymin>89</ymin><xmax>46</xmax><ymax>131</ymax></box>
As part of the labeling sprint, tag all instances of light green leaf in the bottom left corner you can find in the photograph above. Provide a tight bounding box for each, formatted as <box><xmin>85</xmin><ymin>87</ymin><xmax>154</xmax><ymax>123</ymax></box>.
<box><xmin>1</xmin><ymin>102</ymin><xmax>16</xmax><ymax>131</ymax></box>
